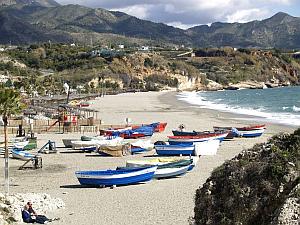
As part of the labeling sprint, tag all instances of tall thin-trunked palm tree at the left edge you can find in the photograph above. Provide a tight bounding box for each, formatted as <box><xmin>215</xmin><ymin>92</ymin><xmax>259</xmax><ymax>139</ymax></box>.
<box><xmin>0</xmin><ymin>88</ymin><xmax>23</xmax><ymax>194</ymax></box>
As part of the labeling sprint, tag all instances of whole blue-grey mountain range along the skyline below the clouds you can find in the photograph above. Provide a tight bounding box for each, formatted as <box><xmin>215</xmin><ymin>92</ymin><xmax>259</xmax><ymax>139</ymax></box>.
<box><xmin>0</xmin><ymin>0</ymin><xmax>300</xmax><ymax>49</ymax></box>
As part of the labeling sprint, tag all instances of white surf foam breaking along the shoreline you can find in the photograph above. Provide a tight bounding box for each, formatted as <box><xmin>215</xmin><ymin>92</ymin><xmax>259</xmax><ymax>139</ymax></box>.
<box><xmin>177</xmin><ymin>92</ymin><xmax>300</xmax><ymax>126</ymax></box>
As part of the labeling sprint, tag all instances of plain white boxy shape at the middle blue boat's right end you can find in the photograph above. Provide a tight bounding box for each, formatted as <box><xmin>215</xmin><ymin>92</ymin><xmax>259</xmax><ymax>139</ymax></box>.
<box><xmin>194</xmin><ymin>139</ymin><xmax>220</xmax><ymax>156</ymax></box>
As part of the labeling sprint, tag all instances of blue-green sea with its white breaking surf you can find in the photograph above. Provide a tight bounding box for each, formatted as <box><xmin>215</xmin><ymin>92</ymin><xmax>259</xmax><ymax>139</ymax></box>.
<box><xmin>177</xmin><ymin>86</ymin><xmax>300</xmax><ymax>126</ymax></box>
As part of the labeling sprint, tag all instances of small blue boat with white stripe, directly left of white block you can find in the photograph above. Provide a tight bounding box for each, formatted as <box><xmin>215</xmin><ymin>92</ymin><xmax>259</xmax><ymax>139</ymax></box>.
<box><xmin>154</xmin><ymin>142</ymin><xmax>195</xmax><ymax>156</ymax></box>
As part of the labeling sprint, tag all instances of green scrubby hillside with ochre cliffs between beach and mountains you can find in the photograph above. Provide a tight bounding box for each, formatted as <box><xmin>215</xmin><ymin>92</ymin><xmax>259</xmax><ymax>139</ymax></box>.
<box><xmin>0</xmin><ymin>43</ymin><xmax>300</xmax><ymax>95</ymax></box>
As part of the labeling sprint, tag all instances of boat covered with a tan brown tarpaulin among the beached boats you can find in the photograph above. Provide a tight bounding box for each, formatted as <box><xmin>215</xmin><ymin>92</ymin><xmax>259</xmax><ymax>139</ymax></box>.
<box><xmin>97</xmin><ymin>144</ymin><xmax>131</xmax><ymax>157</ymax></box>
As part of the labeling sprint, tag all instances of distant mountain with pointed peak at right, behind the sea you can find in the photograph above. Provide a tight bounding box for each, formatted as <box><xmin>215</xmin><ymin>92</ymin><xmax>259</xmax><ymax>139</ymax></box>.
<box><xmin>187</xmin><ymin>12</ymin><xmax>300</xmax><ymax>48</ymax></box>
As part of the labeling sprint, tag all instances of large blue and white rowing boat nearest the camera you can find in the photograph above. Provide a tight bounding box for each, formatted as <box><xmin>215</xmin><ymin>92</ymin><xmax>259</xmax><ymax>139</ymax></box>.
<box><xmin>75</xmin><ymin>166</ymin><xmax>157</xmax><ymax>186</ymax></box>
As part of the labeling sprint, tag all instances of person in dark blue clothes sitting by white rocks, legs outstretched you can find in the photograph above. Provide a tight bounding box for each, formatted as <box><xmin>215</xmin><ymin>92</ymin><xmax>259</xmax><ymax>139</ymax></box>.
<box><xmin>22</xmin><ymin>202</ymin><xmax>58</xmax><ymax>224</ymax></box>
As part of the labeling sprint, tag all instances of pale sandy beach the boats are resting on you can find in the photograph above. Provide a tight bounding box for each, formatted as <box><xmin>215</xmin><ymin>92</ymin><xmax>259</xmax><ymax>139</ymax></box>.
<box><xmin>0</xmin><ymin>92</ymin><xmax>294</xmax><ymax>225</ymax></box>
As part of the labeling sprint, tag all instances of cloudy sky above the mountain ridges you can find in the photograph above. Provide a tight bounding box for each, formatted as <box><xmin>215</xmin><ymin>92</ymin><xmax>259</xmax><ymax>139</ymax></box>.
<box><xmin>56</xmin><ymin>0</ymin><xmax>300</xmax><ymax>29</ymax></box>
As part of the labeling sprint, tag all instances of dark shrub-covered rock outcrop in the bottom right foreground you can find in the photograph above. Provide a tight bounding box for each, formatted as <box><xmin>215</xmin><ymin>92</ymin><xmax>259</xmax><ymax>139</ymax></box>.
<box><xmin>194</xmin><ymin>129</ymin><xmax>300</xmax><ymax>225</ymax></box>
